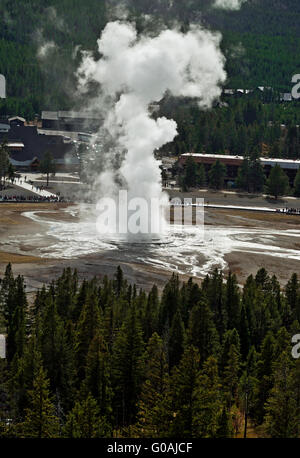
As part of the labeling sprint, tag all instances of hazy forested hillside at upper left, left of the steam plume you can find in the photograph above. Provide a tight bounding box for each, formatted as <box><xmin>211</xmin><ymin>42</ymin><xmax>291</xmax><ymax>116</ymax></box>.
<box><xmin>0</xmin><ymin>0</ymin><xmax>106</xmax><ymax>118</ymax></box>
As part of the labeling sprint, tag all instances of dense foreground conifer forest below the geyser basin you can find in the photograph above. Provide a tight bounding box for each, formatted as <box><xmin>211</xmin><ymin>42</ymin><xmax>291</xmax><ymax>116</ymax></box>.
<box><xmin>0</xmin><ymin>265</ymin><xmax>300</xmax><ymax>438</ymax></box>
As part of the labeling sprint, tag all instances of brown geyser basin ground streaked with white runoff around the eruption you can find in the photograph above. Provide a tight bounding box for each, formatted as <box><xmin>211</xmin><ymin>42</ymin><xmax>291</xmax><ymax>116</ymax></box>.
<box><xmin>0</xmin><ymin>204</ymin><xmax>300</xmax><ymax>290</ymax></box>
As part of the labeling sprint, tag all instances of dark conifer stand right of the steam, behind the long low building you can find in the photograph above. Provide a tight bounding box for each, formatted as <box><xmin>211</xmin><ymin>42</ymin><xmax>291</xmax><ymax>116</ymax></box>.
<box><xmin>160</xmin><ymin>93</ymin><xmax>300</xmax><ymax>159</ymax></box>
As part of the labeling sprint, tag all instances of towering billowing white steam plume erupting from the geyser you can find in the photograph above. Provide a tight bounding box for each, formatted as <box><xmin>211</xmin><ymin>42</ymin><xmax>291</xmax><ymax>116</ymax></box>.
<box><xmin>78</xmin><ymin>21</ymin><xmax>226</xmax><ymax>234</ymax></box>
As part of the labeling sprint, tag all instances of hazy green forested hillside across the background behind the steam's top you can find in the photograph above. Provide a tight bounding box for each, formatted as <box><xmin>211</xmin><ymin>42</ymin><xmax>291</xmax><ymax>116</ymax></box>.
<box><xmin>0</xmin><ymin>0</ymin><xmax>300</xmax><ymax>118</ymax></box>
